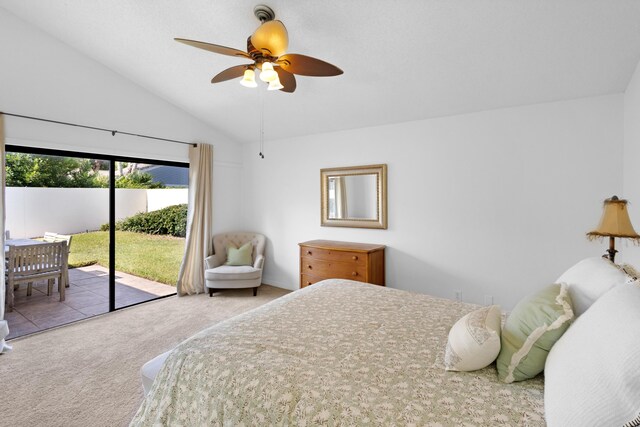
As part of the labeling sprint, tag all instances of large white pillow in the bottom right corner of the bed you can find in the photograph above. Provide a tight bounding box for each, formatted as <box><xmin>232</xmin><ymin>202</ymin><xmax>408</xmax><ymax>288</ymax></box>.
<box><xmin>544</xmin><ymin>284</ymin><xmax>640</xmax><ymax>427</ymax></box>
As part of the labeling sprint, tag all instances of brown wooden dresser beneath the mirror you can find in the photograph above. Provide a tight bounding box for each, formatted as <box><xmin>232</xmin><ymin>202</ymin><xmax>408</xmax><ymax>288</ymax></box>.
<box><xmin>299</xmin><ymin>240</ymin><xmax>385</xmax><ymax>288</ymax></box>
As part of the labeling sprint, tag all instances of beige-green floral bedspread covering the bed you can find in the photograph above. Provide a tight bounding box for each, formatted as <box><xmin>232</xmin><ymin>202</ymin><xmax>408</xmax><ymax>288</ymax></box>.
<box><xmin>131</xmin><ymin>279</ymin><xmax>545</xmax><ymax>426</ymax></box>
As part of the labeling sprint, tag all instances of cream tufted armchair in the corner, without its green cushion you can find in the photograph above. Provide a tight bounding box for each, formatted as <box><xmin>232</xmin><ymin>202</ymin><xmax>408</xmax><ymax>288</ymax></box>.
<box><xmin>204</xmin><ymin>232</ymin><xmax>266</xmax><ymax>296</ymax></box>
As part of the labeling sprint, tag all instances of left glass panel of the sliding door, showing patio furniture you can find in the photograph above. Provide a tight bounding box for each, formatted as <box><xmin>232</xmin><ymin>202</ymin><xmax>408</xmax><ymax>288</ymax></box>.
<box><xmin>5</xmin><ymin>151</ymin><xmax>109</xmax><ymax>338</ymax></box>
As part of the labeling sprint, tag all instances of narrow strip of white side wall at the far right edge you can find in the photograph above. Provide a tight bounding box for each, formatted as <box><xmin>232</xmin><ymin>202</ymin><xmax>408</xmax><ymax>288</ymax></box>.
<box><xmin>616</xmin><ymin>57</ymin><xmax>640</xmax><ymax>268</ymax></box>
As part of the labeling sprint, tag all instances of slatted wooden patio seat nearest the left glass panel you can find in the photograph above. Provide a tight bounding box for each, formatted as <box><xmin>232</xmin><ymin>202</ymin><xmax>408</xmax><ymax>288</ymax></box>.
<box><xmin>5</xmin><ymin>242</ymin><xmax>68</xmax><ymax>311</ymax></box>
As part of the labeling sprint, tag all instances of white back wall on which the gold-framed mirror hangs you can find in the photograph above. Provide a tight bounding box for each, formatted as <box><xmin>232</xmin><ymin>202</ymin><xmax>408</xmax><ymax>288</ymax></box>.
<box><xmin>243</xmin><ymin>95</ymin><xmax>623</xmax><ymax>308</ymax></box>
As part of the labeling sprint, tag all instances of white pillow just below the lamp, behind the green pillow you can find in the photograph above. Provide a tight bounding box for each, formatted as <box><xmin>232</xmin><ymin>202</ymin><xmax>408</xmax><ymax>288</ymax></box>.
<box><xmin>555</xmin><ymin>257</ymin><xmax>633</xmax><ymax>317</ymax></box>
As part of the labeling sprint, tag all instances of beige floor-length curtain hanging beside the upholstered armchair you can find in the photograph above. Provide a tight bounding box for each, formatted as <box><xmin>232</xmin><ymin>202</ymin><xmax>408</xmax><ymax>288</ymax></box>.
<box><xmin>177</xmin><ymin>144</ymin><xmax>213</xmax><ymax>295</ymax></box>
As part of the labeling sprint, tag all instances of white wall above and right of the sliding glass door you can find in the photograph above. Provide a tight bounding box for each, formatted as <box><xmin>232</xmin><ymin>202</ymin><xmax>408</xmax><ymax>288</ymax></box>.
<box><xmin>0</xmin><ymin>8</ymin><xmax>242</xmax><ymax>234</ymax></box>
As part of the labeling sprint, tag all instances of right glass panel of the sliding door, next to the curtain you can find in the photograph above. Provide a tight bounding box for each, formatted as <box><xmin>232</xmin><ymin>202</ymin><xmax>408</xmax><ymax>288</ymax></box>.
<box><xmin>114</xmin><ymin>161</ymin><xmax>182</xmax><ymax>309</ymax></box>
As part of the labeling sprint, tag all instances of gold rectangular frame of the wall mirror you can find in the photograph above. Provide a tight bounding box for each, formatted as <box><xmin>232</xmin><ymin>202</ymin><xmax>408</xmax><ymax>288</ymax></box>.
<box><xmin>320</xmin><ymin>164</ymin><xmax>387</xmax><ymax>229</ymax></box>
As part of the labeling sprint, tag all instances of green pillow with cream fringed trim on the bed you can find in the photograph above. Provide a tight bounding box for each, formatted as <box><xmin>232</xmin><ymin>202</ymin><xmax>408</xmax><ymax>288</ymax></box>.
<box><xmin>496</xmin><ymin>284</ymin><xmax>574</xmax><ymax>383</ymax></box>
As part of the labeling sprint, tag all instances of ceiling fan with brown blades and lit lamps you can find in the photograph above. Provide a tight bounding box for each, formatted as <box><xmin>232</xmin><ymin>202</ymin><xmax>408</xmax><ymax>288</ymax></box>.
<box><xmin>175</xmin><ymin>5</ymin><xmax>342</xmax><ymax>93</ymax></box>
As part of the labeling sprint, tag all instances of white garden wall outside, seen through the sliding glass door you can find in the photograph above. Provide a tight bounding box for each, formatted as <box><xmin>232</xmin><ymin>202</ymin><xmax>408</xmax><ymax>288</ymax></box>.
<box><xmin>5</xmin><ymin>187</ymin><xmax>188</xmax><ymax>238</ymax></box>
